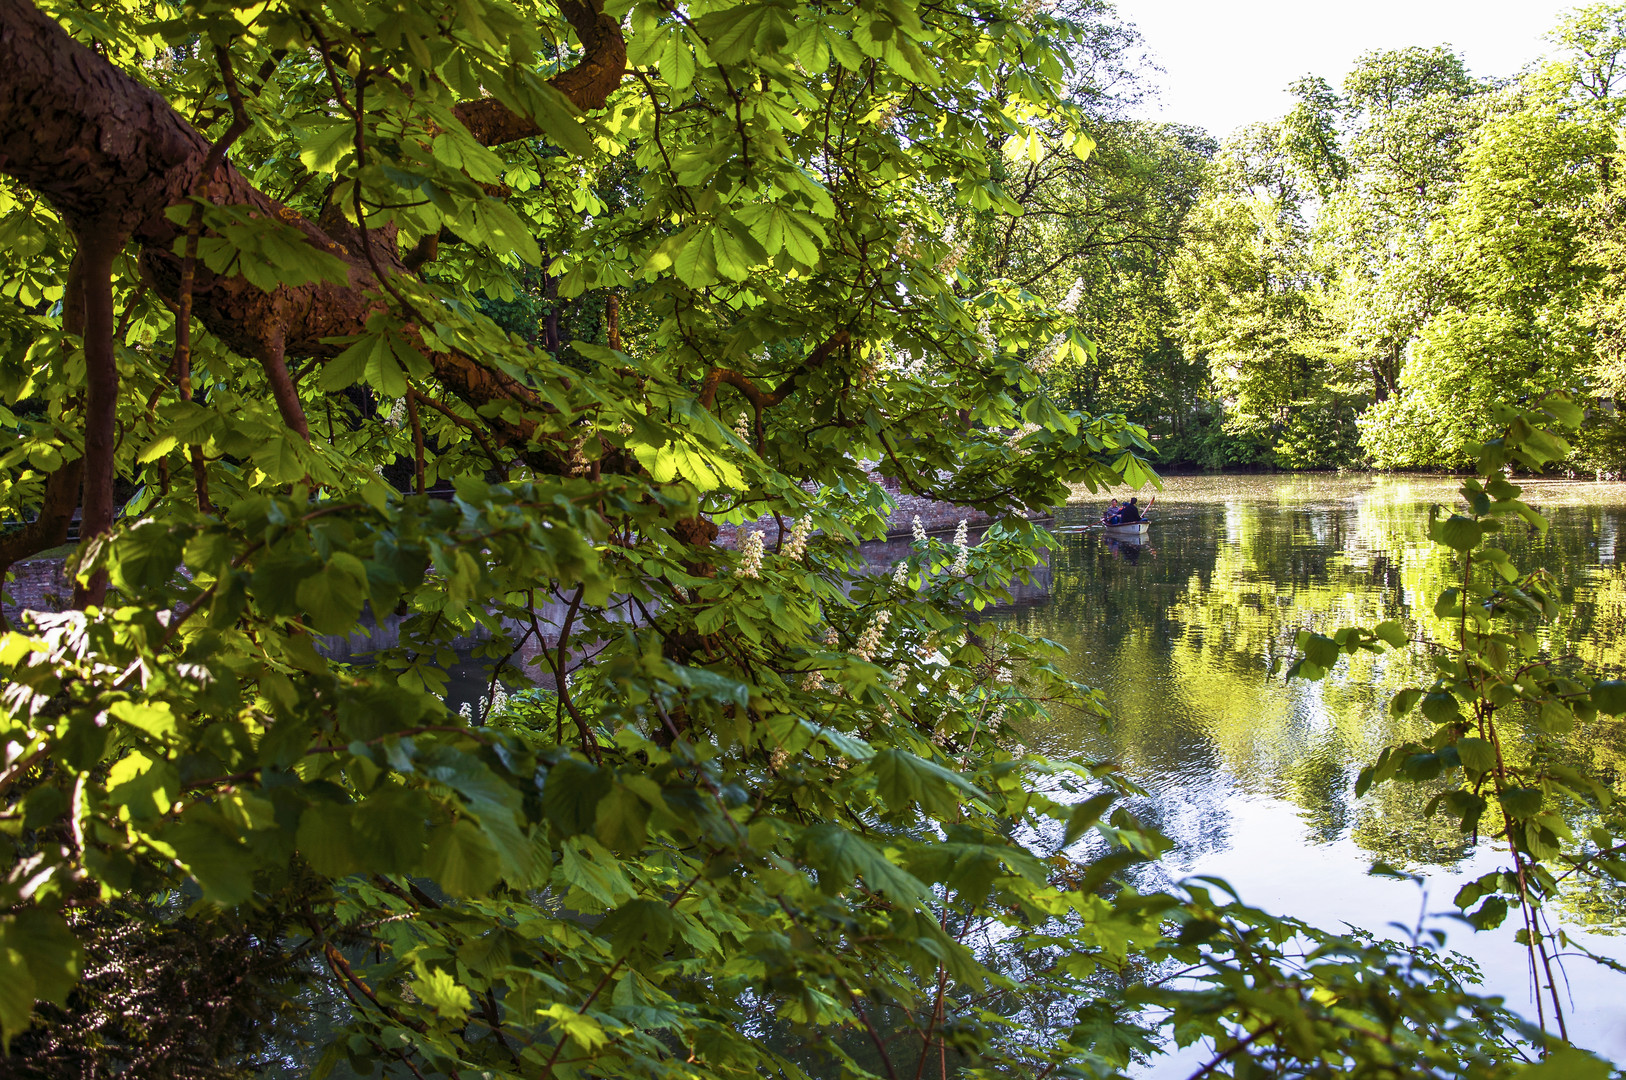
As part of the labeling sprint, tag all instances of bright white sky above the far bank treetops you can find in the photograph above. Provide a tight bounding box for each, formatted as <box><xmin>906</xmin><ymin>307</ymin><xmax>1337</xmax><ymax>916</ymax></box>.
<box><xmin>1117</xmin><ymin>0</ymin><xmax>1577</xmax><ymax>138</ymax></box>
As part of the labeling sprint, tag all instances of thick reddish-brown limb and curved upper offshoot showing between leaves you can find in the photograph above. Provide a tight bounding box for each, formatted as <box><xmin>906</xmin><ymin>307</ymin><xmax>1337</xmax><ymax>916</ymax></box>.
<box><xmin>0</xmin><ymin>0</ymin><xmax>626</xmax><ymax>458</ymax></box>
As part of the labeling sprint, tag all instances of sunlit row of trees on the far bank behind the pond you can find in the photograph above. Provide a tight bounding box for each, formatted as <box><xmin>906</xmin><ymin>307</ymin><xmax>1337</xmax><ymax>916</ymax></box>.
<box><xmin>967</xmin><ymin>5</ymin><xmax>1626</xmax><ymax>475</ymax></box>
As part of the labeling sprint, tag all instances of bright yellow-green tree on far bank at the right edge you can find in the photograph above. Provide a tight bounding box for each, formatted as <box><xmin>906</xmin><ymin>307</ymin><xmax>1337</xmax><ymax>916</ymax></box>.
<box><xmin>1363</xmin><ymin>10</ymin><xmax>1619</xmax><ymax>468</ymax></box>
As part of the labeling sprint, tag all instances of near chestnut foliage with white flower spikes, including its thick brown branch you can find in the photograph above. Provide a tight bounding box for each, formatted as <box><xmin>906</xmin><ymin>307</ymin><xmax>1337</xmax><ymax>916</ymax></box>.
<box><xmin>0</xmin><ymin>0</ymin><xmax>1626</xmax><ymax>1080</ymax></box>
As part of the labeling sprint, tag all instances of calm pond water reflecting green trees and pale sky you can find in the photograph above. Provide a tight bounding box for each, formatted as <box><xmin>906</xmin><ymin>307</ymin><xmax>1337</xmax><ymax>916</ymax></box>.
<box><xmin>1005</xmin><ymin>475</ymin><xmax>1626</xmax><ymax>1077</ymax></box>
